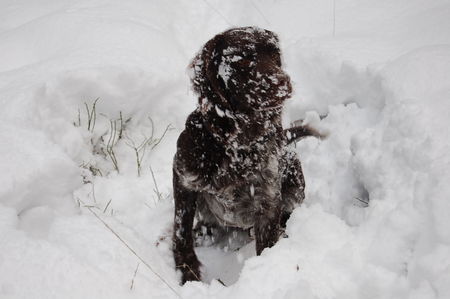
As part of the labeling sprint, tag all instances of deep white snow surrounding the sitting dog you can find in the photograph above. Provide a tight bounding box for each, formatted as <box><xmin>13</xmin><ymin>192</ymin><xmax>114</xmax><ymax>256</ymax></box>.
<box><xmin>0</xmin><ymin>0</ymin><xmax>450</xmax><ymax>299</ymax></box>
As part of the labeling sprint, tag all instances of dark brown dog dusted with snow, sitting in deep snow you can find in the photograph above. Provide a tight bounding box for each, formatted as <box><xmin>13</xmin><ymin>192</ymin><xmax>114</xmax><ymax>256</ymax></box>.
<box><xmin>173</xmin><ymin>27</ymin><xmax>320</xmax><ymax>284</ymax></box>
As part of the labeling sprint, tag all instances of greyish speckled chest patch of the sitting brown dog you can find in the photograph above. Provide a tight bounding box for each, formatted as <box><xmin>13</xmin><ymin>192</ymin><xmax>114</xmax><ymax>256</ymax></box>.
<box><xmin>203</xmin><ymin>148</ymin><xmax>281</xmax><ymax>228</ymax></box>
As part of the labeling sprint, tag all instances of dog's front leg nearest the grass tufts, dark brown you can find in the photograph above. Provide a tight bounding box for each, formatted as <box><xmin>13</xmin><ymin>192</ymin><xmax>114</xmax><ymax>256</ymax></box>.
<box><xmin>173</xmin><ymin>171</ymin><xmax>200</xmax><ymax>284</ymax></box>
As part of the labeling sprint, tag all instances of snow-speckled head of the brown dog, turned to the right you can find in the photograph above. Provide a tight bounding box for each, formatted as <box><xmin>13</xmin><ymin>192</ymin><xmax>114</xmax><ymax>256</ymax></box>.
<box><xmin>190</xmin><ymin>27</ymin><xmax>292</xmax><ymax>115</ymax></box>
